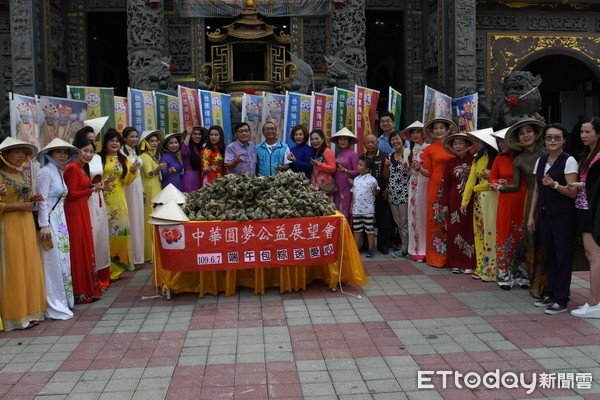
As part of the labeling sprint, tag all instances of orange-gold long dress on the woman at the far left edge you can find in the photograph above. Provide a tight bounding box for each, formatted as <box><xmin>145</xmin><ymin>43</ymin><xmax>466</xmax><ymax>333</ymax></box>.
<box><xmin>0</xmin><ymin>172</ymin><xmax>46</xmax><ymax>331</ymax></box>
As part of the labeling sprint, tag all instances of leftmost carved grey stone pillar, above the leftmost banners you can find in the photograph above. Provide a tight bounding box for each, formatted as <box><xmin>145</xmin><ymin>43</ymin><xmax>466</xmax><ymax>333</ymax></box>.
<box><xmin>10</xmin><ymin>0</ymin><xmax>42</xmax><ymax>96</ymax></box>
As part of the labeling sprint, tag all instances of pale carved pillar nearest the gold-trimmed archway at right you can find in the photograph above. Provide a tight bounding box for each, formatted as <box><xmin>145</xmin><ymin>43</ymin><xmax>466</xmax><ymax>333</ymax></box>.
<box><xmin>445</xmin><ymin>0</ymin><xmax>477</xmax><ymax>97</ymax></box>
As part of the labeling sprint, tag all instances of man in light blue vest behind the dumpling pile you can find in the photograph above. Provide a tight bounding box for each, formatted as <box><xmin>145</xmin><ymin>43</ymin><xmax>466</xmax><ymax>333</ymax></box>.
<box><xmin>256</xmin><ymin>122</ymin><xmax>292</xmax><ymax>176</ymax></box>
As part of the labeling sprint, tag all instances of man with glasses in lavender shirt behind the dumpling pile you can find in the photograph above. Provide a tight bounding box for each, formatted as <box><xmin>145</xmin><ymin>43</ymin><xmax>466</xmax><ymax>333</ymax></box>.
<box><xmin>225</xmin><ymin>122</ymin><xmax>256</xmax><ymax>176</ymax></box>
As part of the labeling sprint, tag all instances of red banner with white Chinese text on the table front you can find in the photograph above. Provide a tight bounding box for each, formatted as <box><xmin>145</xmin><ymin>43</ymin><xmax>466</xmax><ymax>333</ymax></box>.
<box><xmin>154</xmin><ymin>215</ymin><xmax>340</xmax><ymax>271</ymax></box>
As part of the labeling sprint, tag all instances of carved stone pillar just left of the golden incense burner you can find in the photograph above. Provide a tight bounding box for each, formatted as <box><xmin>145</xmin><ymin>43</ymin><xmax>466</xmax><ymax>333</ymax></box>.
<box><xmin>127</xmin><ymin>0</ymin><xmax>171</xmax><ymax>89</ymax></box>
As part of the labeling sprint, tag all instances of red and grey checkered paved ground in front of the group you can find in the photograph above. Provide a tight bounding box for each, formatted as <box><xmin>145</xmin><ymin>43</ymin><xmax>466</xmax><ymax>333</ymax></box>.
<box><xmin>0</xmin><ymin>254</ymin><xmax>600</xmax><ymax>400</ymax></box>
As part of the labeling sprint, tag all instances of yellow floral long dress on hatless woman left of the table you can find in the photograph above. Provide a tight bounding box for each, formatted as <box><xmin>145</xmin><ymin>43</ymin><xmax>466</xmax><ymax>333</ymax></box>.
<box><xmin>104</xmin><ymin>155</ymin><xmax>137</xmax><ymax>280</ymax></box>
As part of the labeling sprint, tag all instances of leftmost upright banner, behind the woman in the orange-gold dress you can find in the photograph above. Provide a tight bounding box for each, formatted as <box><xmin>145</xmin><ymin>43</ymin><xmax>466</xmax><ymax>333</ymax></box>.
<box><xmin>9</xmin><ymin>93</ymin><xmax>42</xmax><ymax>149</ymax></box>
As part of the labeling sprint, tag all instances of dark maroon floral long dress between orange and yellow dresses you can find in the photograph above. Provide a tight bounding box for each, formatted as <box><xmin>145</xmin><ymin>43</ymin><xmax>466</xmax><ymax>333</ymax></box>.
<box><xmin>442</xmin><ymin>154</ymin><xmax>475</xmax><ymax>269</ymax></box>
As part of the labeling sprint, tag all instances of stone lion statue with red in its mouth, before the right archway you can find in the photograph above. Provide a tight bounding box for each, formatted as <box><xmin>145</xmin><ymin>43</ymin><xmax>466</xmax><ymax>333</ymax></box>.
<box><xmin>491</xmin><ymin>71</ymin><xmax>545</xmax><ymax>130</ymax></box>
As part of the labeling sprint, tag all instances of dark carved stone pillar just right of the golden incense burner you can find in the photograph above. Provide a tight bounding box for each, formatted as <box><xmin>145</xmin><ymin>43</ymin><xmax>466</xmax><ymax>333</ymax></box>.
<box><xmin>330</xmin><ymin>0</ymin><xmax>367</xmax><ymax>87</ymax></box>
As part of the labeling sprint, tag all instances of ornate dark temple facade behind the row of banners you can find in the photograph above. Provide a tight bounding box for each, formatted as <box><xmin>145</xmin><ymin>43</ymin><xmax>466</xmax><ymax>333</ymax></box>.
<box><xmin>0</xmin><ymin>0</ymin><xmax>600</xmax><ymax>129</ymax></box>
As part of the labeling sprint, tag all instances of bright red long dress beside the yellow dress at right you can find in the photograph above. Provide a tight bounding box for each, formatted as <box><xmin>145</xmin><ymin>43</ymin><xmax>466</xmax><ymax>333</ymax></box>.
<box><xmin>490</xmin><ymin>153</ymin><xmax>527</xmax><ymax>283</ymax></box>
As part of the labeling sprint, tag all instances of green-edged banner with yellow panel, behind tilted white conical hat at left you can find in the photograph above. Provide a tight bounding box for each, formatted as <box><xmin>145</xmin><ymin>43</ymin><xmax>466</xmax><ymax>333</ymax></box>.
<box><xmin>67</xmin><ymin>86</ymin><xmax>115</xmax><ymax>132</ymax></box>
